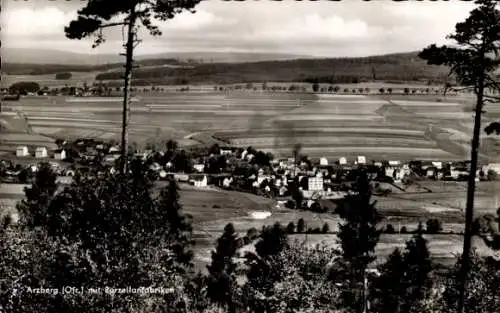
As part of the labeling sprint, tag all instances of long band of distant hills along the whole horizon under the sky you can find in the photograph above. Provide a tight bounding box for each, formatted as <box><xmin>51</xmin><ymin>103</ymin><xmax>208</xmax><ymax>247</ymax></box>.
<box><xmin>2</xmin><ymin>48</ymin><xmax>448</xmax><ymax>85</ymax></box>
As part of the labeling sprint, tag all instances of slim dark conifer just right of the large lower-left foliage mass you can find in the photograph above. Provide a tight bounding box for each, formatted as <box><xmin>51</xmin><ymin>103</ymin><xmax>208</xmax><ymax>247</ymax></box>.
<box><xmin>207</xmin><ymin>224</ymin><xmax>238</xmax><ymax>313</ymax></box>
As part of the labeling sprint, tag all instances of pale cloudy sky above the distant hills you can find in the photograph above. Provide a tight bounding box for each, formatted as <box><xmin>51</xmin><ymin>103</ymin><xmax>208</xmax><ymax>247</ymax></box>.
<box><xmin>1</xmin><ymin>0</ymin><xmax>474</xmax><ymax>57</ymax></box>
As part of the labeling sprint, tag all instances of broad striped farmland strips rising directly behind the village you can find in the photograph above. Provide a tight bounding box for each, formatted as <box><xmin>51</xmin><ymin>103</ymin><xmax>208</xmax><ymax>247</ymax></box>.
<box><xmin>4</xmin><ymin>91</ymin><xmax>500</xmax><ymax>161</ymax></box>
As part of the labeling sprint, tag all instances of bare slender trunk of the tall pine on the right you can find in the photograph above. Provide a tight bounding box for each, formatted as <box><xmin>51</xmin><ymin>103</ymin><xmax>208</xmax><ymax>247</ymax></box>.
<box><xmin>458</xmin><ymin>77</ymin><xmax>484</xmax><ymax>313</ymax></box>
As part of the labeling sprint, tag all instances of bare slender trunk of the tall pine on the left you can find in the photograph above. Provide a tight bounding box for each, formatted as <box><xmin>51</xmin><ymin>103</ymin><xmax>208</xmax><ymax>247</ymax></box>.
<box><xmin>120</xmin><ymin>8</ymin><xmax>136</xmax><ymax>174</ymax></box>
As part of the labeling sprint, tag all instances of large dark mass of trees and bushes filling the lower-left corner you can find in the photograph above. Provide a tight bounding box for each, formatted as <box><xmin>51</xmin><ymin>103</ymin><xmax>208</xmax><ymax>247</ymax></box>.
<box><xmin>0</xmin><ymin>162</ymin><xmax>196</xmax><ymax>313</ymax></box>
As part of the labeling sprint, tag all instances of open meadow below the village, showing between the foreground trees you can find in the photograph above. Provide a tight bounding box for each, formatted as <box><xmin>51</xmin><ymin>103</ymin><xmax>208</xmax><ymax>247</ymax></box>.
<box><xmin>0</xmin><ymin>182</ymin><xmax>500</xmax><ymax>269</ymax></box>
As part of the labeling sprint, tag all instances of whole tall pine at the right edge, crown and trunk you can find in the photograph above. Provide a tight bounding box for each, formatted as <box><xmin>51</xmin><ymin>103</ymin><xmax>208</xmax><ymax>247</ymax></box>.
<box><xmin>419</xmin><ymin>0</ymin><xmax>500</xmax><ymax>313</ymax></box>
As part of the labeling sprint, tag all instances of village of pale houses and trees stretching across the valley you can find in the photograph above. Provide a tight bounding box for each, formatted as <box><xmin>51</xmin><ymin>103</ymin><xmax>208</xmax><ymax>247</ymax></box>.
<box><xmin>0</xmin><ymin>139</ymin><xmax>500</xmax><ymax>211</ymax></box>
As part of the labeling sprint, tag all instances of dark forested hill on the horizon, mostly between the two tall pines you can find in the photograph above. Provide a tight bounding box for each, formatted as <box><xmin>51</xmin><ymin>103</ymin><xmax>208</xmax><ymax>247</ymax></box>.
<box><xmin>96</xmin><ymin>53</ymin><xmax>448</xmax><ymax>84</ymax></box>
